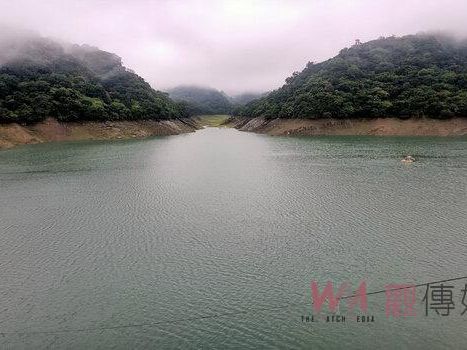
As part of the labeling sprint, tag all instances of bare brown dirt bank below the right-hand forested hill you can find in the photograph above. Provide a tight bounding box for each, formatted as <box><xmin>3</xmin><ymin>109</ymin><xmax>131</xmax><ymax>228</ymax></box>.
<box><xmin>228</xmin><ymin>117</ymin><xmax>467</xmax><ymax>136</ymax></box>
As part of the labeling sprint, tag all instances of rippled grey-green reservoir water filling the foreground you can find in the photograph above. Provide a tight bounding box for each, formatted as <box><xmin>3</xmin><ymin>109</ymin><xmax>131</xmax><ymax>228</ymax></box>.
<box><xmin>0</xmin><ymin>128</ymin><xmax>467</xmax><ymax>349</ymax></box>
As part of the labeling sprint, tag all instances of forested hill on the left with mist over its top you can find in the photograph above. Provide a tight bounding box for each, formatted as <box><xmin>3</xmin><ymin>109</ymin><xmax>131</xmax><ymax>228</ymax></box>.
<box><xmin>0</xmin><ymin>31</ymin><xmax>186</xmax><ymax>122</ymax></box>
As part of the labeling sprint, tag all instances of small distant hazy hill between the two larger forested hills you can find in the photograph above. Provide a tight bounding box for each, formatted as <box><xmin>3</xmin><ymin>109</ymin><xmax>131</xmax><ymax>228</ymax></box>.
<box><xmin>168</xmin><ymin>86</ymin><xmax>232</xmax><ymax>115</ymax></box>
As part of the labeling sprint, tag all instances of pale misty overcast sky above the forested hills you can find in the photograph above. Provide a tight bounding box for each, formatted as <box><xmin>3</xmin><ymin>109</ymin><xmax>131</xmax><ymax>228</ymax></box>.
<box><xmin>0</xmin><ymin>0</ymin><xmax>467</xmax><ymax>94</ymax></box>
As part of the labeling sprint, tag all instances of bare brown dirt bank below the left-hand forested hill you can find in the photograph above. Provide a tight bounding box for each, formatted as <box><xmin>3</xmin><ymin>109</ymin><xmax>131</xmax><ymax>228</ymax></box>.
<box><xmin>0</xmin><ymin>118</ymin><xmax>199</xmax><ymax>149</ymax></box>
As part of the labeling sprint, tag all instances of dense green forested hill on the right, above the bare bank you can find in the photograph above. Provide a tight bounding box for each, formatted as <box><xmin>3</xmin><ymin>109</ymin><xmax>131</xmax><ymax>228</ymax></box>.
<box><xmin>239</xmin><ymin>34</ymin><xmax>467</xmax><ymax>118</ymax></box>
